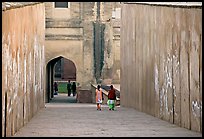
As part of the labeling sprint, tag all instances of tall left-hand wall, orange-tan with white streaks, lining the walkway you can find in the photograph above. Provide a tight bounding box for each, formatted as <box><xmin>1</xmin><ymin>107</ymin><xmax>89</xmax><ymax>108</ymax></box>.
<box><xmin>2</xmin><ymin>3</ymin><xmax>45</xmax><ymax>137</ymax></box>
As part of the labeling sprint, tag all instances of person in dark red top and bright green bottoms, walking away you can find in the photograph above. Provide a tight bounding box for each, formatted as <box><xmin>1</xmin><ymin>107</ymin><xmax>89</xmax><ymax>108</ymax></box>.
<box><xmin>107</xmin><ymin>85</ymin><xmax>116</xmax><ymax>110</ymax></box>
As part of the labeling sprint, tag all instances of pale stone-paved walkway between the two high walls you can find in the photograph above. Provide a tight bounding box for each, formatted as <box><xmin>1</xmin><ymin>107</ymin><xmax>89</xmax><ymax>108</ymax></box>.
<box><xmin>14</xmin><ymin>94</ymin><xmax>202</xmax><ymax>137</ymax></box>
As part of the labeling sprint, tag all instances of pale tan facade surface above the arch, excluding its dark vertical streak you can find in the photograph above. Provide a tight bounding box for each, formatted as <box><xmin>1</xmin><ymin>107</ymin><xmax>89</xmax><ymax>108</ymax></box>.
<box><xmin>45</xmin><ymin>2</ymin><xmax>120</xmax><ymax>90</ymax></box>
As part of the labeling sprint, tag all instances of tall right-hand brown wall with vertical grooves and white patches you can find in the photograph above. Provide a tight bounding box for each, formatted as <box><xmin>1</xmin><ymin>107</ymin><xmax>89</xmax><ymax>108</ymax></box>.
<box><xmin>120</xmin><ymin>3</ymin><xmax>202</xmax><ymax>132</ymax></box>
